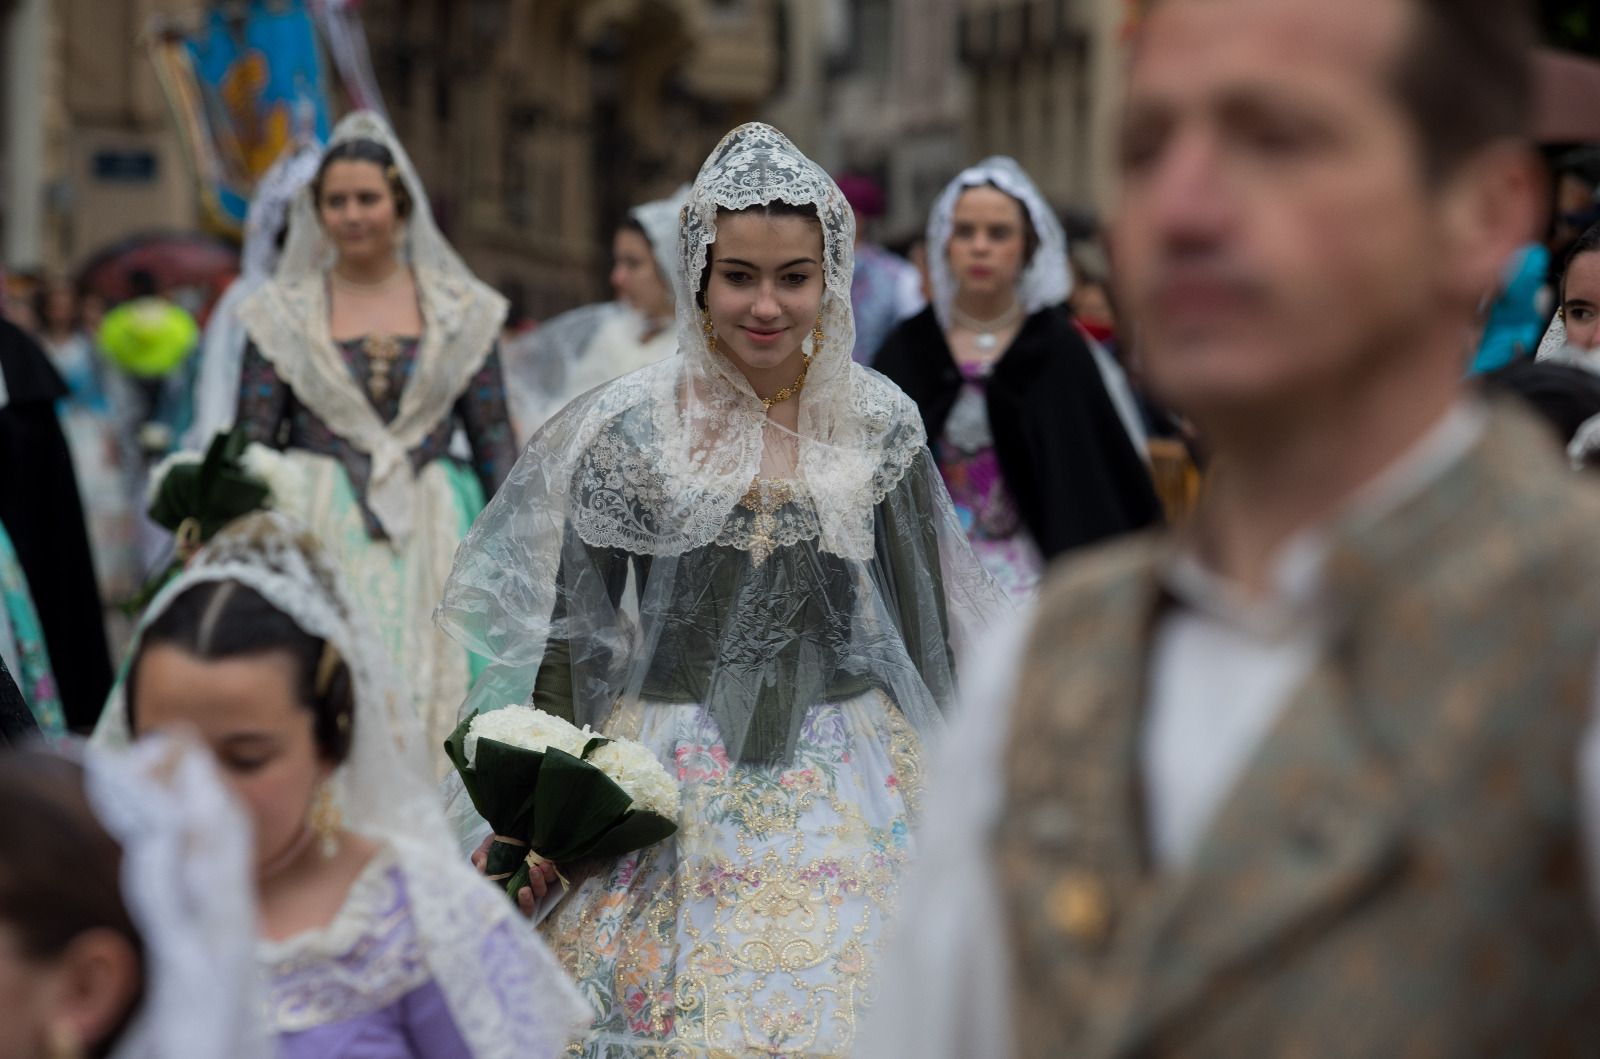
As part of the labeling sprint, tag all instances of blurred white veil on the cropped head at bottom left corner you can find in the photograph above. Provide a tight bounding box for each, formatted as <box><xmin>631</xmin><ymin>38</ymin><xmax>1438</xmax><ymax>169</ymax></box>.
<box><xmin>72</xmin><ymin>736</ymin><xmax>272</xmax><ymax>1059</ymax></box>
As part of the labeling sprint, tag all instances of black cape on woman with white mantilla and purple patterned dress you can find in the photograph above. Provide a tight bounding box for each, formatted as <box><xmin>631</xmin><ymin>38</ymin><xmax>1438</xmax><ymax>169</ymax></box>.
<box><xmin>872</xmin><ymin>306</ymin><xmax>1162</xmax><ymax>558</ymax></box>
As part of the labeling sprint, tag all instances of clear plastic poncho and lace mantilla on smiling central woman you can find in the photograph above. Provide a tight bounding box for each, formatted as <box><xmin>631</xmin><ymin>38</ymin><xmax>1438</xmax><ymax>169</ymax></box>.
<box><xmin>438</xmin><ymin>123</ymin><xmax>1006</xmax><ymax>763</ymax></box>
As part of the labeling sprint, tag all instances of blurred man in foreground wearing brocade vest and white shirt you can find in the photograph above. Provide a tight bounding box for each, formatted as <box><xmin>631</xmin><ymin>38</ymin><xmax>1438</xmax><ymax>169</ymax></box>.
<box><xmin>864</xmin><ymin>0</ymin><xmax>1600</xmax><ymax>1057</ymax></box>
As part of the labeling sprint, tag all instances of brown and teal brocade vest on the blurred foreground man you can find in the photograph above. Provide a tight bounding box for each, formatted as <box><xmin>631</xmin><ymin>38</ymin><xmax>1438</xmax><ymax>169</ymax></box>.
<box><xmin>995</xmin><ymin>410</ymin><xmax>1600</xmax><ymax>1059</ymax></box>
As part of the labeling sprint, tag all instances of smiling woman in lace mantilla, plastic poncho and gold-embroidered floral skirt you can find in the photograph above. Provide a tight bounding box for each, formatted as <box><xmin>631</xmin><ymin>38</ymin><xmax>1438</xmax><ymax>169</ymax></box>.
<box><xmin>440</xmin><ymin>125</ymin><xmax>1003</xmax><ymax>1056</ymax></box>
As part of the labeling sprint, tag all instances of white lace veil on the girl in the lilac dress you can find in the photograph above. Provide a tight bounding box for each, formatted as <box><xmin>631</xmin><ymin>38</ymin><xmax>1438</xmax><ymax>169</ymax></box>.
<box><xmin>96</xmin><ymin>512</ymin><xmax>589</xmax><ymax>1059</ymax></box>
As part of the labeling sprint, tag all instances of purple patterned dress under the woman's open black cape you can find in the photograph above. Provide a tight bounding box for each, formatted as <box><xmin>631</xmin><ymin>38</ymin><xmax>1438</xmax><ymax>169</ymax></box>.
<box><xmin>933</xmin><ymin>365</ymin><xmax>1045</xmax><ymax>603</ymax></box>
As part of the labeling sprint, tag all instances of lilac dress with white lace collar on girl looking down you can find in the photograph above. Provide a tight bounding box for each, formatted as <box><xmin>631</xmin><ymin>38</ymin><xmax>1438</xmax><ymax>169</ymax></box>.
<box><xmin>259</xmin><ymin>848</ymin><xmax>472</xmax><ymax>1059</ymax></box>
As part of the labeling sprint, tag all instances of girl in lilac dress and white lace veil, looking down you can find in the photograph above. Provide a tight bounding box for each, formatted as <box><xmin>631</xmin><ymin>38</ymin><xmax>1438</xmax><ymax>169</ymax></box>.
<box><xmin>102</xmin><ymin>514</ymin><xmax>582</xmax><ymax>1059</ymax></box>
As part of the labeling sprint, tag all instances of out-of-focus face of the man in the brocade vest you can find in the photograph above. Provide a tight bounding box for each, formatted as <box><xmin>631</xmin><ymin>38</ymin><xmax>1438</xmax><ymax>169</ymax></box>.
<box><xmin>1112</xmin><ymin>0</ymin><xmax>1499</xmax><ymax>426</ymax></box>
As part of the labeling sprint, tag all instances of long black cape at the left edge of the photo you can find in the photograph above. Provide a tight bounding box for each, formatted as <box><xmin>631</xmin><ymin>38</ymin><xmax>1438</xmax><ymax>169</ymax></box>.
<box><xmin>0</xmin><ymin>320</ymin><xmax>110</xmax><ymax>731</ymax></box>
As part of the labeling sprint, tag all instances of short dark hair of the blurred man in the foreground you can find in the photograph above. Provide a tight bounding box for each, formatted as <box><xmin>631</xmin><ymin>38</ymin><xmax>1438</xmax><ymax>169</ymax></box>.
<box><xmin>1142</xmin><ymin>0</ymin><xmax>1538</xmax><ymax>182</ymax></box>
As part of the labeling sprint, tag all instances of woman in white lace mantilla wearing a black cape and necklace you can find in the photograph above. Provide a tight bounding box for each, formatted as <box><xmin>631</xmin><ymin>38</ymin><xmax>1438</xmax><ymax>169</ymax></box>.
<box><xmin>872</xmin><ymin>157</ymin><xmax>1160</xmax><ymax>601</ymax></box>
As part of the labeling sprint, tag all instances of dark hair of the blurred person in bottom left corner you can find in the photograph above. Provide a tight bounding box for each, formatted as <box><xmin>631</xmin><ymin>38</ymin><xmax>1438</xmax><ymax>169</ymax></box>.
<box><xmin>0</xmin><ymin>750</ymin><xmax>144</xmax><ymax>1056</ymax></box>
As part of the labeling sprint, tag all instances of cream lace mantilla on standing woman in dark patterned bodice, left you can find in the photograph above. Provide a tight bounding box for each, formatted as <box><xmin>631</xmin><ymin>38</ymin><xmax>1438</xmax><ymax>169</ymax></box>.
<box><xmin>238</xmin><ymin>110</ymin><xmax>507</xmax><ymax>541</ymax></box>
